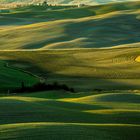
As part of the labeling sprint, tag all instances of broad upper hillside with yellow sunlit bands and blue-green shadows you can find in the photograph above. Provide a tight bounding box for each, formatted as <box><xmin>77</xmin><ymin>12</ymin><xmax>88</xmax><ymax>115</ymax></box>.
<box><xmin>0</xmin><ymin>2</ymin><xmax>140</xmax><ymax>50</ymax></box>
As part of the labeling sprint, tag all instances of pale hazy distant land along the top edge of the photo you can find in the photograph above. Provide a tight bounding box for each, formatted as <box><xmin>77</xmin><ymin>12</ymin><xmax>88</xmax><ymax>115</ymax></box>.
<box><xmin>0</xmin><ymin>0</ymin><xmax>137</xmax><ymax>5</ymax></box>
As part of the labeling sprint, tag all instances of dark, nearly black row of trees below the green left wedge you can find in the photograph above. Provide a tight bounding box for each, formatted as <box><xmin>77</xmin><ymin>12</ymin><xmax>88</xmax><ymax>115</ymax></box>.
<box><xmin>12</xmin><ymin>82</ymin><xmax>75</xmax><ymax>93</ymax></box>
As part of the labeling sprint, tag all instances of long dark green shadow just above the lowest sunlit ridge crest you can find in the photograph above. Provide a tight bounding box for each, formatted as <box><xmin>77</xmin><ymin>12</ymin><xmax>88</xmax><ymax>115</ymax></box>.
<box><xmin>0</xmin><ymin>100</ymin><xmax>140</xmax><ymax>124</ymax></box>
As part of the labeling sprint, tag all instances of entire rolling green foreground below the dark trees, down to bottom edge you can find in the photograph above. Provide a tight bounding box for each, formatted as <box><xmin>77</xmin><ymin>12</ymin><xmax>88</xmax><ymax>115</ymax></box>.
<box><xmin>0</xmin><ymin>92</ymin><xmax>140</xmax><ymax>140</ymax></box>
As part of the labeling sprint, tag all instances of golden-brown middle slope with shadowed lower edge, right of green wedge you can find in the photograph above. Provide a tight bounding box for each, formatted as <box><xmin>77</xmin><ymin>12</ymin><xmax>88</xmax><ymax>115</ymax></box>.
<box><xmin>0</xmin><ymin>47</ymin><xmax>140</xmax><ymax>90</ymax></box>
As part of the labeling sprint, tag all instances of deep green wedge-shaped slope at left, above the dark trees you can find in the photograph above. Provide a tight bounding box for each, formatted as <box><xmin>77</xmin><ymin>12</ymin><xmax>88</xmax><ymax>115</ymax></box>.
<box><xmin>0</xmin><ymin>61</ymin><xmax>38</xmax><ymax>90</ymax></box>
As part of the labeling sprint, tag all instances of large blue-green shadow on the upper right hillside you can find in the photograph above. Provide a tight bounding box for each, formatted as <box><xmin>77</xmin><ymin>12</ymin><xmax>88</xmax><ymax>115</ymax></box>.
<box><xmin>65</xmin><ymin>14</ymin><xmax>140</xmax><ymax>48</ymax></box>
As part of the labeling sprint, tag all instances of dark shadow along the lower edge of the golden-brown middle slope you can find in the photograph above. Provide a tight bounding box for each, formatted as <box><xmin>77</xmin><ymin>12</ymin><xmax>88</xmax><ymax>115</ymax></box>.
<box><xmin>6</xmin><ymin>60</ymin><xmax>140</xmax><ymax>91</ymax></box>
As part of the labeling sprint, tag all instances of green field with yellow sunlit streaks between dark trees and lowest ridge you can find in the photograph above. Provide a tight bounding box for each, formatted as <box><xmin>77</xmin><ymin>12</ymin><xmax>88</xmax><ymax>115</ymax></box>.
<box><xmin>0</xmin><ymin>92</ymin><xmax>140</xmax><ymax>124</ymax></box>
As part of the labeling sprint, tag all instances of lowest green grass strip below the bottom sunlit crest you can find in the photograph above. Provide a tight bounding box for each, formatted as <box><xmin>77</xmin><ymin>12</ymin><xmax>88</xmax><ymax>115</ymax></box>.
<box><xmin>1</xmin><ymin>123</ymin><xmax>139</xmax><ymax>140</ymax></box>
